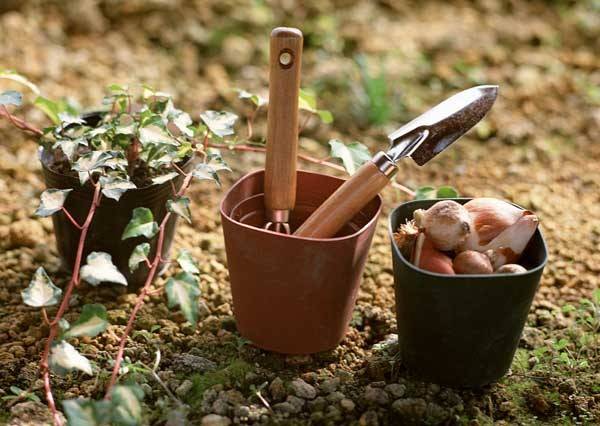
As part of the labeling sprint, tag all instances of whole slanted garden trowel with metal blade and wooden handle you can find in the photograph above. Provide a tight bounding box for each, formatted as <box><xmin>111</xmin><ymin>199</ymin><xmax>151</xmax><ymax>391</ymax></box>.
<box><xmin>294</xmin><ymin>85</ymin><xmax>498</xmax><ymax>238</ymax></box>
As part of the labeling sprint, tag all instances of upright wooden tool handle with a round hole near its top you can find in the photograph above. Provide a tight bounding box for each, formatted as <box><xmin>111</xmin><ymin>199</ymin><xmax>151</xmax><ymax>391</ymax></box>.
<box><xmin>265</xmin><ymin>27</ymin><xmax>302</xmax><ymax>211</ymax></box>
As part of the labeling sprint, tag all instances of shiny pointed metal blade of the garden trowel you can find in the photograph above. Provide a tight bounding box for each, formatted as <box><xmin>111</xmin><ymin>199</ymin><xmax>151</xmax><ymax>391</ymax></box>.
<box><xmin>387</xmin><ymin>85</ymin><xmax>498</xmax><ymax>166</ymax></box>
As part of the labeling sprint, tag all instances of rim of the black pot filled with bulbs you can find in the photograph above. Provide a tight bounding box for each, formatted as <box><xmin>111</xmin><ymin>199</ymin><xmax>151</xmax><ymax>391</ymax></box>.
<box><xmin>388</xmin><ymin>197</ymin><xmax>548</xmax><ymax>280</ymax></box>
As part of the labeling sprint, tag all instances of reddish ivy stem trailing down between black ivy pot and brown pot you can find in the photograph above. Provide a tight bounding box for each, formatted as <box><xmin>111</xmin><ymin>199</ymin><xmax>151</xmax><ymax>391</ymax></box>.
<box><xmin>104</xmin><ymin>173</ymin><xmax>193</xmax><ymax>399</ymax></box>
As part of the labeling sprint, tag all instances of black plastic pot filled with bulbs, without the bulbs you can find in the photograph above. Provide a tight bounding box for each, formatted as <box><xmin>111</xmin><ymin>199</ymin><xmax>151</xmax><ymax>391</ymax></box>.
<box><xmin>389</xmin><ymin>198</ymin><xmax>547</xmax><ymax>387</ymax></box>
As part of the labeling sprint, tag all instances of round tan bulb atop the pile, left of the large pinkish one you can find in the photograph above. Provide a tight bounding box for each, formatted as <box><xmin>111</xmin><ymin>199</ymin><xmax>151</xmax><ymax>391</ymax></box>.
<box><xmin>413</xmin><ymin>200</ymin><xmax>473</xmax><ymax>251</ymax></box>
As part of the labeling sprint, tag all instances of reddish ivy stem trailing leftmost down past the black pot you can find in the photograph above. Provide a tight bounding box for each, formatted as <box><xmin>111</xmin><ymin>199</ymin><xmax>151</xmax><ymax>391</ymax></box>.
<box><xmin>40</xmin><ymin>183</ymin><xmax>102</xmax><ymax>426</ymax></box>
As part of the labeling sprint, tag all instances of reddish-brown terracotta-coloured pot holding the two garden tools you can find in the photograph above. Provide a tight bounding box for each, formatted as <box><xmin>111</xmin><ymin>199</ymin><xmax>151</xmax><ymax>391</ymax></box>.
<box><xmin>221</xmin><ymin>171</ymin><xmax>381</xmax><ymax>354</ymax></box>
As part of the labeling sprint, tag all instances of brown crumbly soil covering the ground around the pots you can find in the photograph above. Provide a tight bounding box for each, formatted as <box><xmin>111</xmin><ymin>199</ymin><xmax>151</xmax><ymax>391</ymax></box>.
<box><xmin>0</xmin><ymin>0</ymin><xmax>600</xmax><ymax>425</ymax></box>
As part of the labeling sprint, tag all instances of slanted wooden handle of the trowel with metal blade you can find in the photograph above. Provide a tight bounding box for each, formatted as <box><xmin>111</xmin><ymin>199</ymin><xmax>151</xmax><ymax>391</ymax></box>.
<box><xmin>294</xmin><ymin>161</ymin><xmax>389</xmax><ymax>238</ymax></box>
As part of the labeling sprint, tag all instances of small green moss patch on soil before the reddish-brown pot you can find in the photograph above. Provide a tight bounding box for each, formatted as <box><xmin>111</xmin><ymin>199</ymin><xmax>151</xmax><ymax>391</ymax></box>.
<box><xmin>186</xmin><ymin>359</ymin><xmax>254</xmax><ymax>405</ymax></box>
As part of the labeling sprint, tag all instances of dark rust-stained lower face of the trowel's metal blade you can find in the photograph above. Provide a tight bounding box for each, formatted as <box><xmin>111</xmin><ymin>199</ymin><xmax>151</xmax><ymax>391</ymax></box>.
<box><xmin>410</xmin><ymin>86</ymin><xmax>498</xmax><ymax>166</ymax></box>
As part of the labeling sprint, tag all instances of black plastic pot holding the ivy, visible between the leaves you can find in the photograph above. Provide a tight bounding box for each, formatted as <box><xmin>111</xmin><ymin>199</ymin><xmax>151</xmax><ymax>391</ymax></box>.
<box><xmin>40</xmin><ymin>113</ymin><xmax>193</xmax><ymax>290</ymax></box>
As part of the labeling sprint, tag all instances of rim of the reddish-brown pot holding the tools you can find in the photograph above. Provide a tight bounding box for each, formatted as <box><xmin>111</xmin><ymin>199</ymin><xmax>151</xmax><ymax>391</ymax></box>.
<box><xmin>219</xmin><ymin>169</ymin><xmax>383</xmax><ymax>242</ymax></box>
